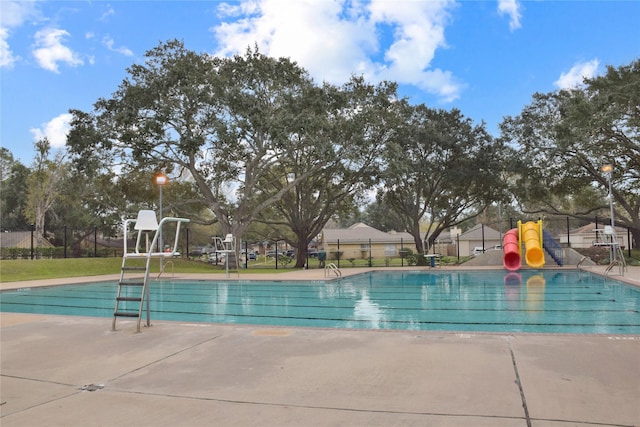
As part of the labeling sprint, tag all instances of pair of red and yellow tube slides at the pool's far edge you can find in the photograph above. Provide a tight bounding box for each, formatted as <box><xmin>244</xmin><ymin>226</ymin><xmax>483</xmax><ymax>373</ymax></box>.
<box><xmin>502</xmin><ymin>221</ymin><xmax>544</xmax><ymax>271</ymax></box>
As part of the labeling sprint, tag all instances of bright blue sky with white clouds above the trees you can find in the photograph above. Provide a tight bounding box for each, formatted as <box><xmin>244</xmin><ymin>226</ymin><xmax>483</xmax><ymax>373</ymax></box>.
<box><xmin>0</xmin><ymin>0</ymin><xmax>640</xmax><ymax>165</ymax></box>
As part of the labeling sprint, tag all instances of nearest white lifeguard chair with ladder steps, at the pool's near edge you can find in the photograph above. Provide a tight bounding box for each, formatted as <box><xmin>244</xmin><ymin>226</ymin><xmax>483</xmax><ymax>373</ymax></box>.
<box><xmin>111</xmin><ymin>210</ymin><xmax>189</xmax><ymax>332</ymax></box>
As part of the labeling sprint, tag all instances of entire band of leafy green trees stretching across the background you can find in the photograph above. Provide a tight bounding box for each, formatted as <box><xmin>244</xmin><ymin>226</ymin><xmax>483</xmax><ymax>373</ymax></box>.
<box><xmin>0</xmin><ymin>40</ymin><xmax>640</xmax><ymax>260</ymax></box>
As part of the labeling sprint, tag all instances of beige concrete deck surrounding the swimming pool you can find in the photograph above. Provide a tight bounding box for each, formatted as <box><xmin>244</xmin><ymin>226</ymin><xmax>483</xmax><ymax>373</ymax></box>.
<box><xmin>0</xmin><ymin>267</ymin><xmax>640</xmax><ymax>427</ymax></box>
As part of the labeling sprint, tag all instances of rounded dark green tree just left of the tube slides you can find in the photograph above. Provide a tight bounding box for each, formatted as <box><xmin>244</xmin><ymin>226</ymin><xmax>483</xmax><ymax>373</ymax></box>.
<box><xmin>378</xmin><ymin>104</ymin><xmax>504</xmax><ymax>253</ymax></box>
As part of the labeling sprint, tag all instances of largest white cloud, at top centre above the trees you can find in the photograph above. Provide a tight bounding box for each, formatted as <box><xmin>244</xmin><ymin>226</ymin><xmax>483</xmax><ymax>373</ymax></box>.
<box><xmin>212</xmin><ymin>0</ymin><xmax>462</xmax><ymax>101</ymax></box>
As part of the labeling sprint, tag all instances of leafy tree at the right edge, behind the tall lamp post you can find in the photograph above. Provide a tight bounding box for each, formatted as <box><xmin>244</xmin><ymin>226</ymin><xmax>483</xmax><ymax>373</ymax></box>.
<box><xmin>500</xmin><ymin>60</ymin><xmax>640</xmax><ymax>247</ymax></box>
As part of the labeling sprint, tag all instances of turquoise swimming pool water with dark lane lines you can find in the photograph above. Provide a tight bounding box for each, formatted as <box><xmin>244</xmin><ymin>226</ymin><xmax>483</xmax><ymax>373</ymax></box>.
<box><xmin>0</xmin><ymin>270</ymin><xmax>640</xmax><ymax>334</ymax></box>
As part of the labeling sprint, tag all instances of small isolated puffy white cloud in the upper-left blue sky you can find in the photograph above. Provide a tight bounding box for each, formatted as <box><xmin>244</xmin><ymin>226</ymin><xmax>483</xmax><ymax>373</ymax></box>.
<box><xmin>33</xmin><ymin>28</ymin><xmax>84</xmax><ymax>73</ymax></box>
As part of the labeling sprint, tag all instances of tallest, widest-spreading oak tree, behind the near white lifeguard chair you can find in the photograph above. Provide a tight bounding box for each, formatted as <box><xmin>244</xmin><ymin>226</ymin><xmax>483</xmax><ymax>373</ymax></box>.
<box><xmin>69</xmin><ymin>40</ymin><xmax>329</xmax><ymax>252</ymax></box>
